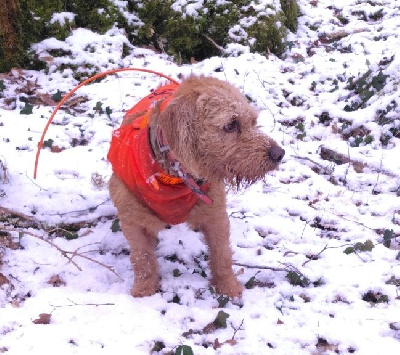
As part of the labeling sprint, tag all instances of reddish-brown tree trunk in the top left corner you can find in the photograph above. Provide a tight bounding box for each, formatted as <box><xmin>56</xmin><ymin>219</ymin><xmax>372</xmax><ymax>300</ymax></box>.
<box><xmin>0</xmin><ymin>0</ymin><xmax>23</xmax><ymax>72</ymax></box>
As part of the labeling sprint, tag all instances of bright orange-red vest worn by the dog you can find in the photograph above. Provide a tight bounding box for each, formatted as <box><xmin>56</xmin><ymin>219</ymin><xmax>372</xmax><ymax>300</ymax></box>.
<box><xmin>107</xmin><ymin>84</ymin><xmax>209</xmax><ymax>224</ymax></box>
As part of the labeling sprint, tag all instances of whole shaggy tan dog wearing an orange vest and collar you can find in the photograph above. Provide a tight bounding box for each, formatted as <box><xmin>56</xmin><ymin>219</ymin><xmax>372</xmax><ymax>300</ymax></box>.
<box><xmin>108</xmin><ymin>76</ymin><xmax>285</xmax><ymax>297</ymax></box>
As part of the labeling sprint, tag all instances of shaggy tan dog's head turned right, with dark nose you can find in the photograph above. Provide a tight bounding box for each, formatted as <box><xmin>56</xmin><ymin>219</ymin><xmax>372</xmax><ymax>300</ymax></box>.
<box><xmin>158</xmin><ymin>76</ymin><xmax>285</xmax><ymax>187</ymax></box>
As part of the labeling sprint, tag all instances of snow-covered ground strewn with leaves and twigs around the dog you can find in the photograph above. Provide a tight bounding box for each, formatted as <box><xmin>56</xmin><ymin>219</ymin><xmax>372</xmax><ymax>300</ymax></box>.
<box><xmin>0</xmin><ymin>0</ymin><xmax>400</xmax><ymax>355</ymax></box>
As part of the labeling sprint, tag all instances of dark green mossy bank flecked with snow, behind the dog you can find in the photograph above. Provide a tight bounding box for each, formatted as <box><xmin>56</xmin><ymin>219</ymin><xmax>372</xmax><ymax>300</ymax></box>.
<box><xmin>0</xmin><ymin>0</ymin><xmax>298</xmax><ymax>71</ymax></box>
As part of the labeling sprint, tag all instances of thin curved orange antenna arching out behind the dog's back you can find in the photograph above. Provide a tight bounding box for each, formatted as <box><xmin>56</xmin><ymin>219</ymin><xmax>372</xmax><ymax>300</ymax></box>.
<box><xmin>33</xmin><ymin>68</ymin><xmax>179</xmax><ymax>179</ymax></box>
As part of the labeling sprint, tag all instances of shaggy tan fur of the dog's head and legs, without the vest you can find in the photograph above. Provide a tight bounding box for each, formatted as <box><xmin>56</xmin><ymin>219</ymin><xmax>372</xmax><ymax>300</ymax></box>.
<box><xmin>110</xmin><ymin>76</ymin><xmax>285</xmax><ymax>297</ymax></box>
